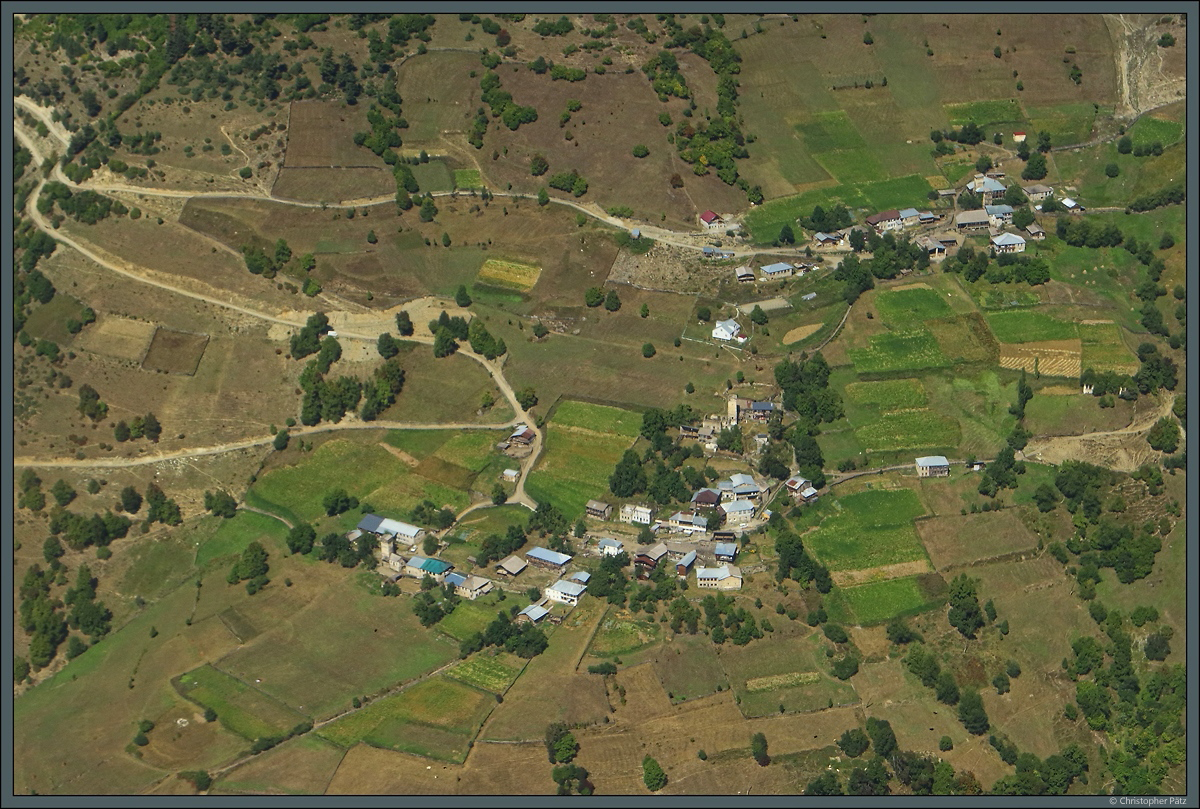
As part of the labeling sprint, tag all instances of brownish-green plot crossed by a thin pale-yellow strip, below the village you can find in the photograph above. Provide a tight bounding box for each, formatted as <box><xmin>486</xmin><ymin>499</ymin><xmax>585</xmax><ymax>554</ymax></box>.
<box><xmin>720</xmin><ymin>633</ymin><xmax>858</xmax><ymax>717</ymax></box>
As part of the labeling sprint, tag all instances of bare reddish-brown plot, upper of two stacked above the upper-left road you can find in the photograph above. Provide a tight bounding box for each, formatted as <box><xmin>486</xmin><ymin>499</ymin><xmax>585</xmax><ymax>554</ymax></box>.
<box><xmin>283</xmin><ymin>101</ymin><xmax>384</xmax><ymax>168</ymax></box>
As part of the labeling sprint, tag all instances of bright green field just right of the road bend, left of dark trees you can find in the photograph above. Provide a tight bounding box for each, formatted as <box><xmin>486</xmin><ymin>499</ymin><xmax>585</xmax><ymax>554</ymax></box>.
<box><xmin>526</xmin><ymin>402</ymin><xmax>641</xmax><ymax>517</ymax></box>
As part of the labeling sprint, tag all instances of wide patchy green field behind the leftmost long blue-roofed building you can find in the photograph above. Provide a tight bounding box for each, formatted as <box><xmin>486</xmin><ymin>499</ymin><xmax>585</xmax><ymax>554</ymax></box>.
<box><xmin>253</xmin><ymin>438</ymin><xmax>467</xmax><ymax>520</ymax></box>
